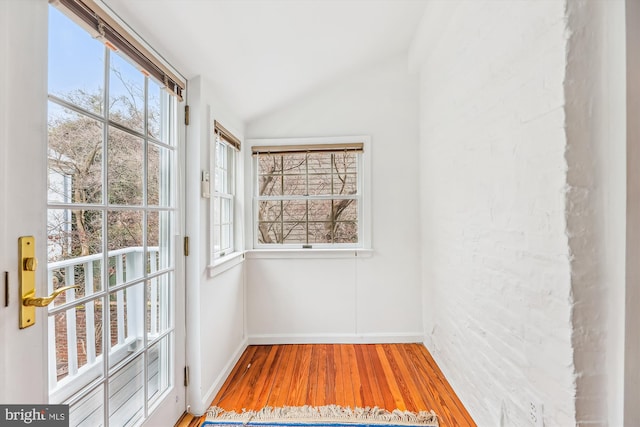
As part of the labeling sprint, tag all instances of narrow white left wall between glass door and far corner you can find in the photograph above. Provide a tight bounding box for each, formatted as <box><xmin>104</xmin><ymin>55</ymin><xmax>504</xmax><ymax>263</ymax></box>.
<box><xmin>186</xmin><ymin>77</ymin><xmax>247</xmax><ymax>415</ymax></box>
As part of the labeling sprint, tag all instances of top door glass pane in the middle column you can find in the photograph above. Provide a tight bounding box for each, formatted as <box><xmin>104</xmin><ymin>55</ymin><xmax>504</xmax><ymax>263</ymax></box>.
<box><xmin>109</xmin><ymin>54</ymin><xmax>145</xmax><ymax>133</ymax></box>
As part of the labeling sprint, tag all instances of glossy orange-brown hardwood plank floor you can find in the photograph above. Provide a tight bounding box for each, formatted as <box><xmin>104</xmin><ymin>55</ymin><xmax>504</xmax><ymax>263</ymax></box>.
<box><xmin>176</xmin><ymin>344</ymin><xmax>476</xmax><ymax>427</ymax></box>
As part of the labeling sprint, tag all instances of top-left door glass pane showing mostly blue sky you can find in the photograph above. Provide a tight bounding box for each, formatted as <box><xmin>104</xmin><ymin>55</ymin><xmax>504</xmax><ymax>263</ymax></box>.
<box><xmin>49</xmin><ymin>7</ymin><xmax>104</xmax><ymax>115</ymax></box>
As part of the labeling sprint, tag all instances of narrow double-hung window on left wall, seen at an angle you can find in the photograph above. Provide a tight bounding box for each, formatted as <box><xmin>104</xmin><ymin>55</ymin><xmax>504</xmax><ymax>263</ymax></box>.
<box><xmin>212</xmin><ymin>121</ymin><xmax>240</xmax><ymax>262</ymax></box>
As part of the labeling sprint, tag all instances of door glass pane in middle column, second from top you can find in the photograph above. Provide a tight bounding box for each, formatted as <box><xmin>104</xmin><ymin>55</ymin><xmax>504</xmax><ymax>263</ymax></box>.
<box><xmin>107</xmin><ymin>127</ymin><xmax>144</xmax><ymax>205</ymax></box>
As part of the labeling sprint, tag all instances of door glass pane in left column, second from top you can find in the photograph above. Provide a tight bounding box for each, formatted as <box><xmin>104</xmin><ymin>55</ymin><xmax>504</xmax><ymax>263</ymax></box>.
<box><xmin>47</xmin><ymin>102</ymin><xmax>103</xmax><ymax>204</ymax></box>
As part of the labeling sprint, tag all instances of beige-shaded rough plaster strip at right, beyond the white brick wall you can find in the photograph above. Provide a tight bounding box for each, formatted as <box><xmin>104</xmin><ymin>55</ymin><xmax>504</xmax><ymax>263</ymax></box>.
<box><xmin>565</xmin><ymin>0</ymin><xmax>624</xmax><ymax>426</ymax></box>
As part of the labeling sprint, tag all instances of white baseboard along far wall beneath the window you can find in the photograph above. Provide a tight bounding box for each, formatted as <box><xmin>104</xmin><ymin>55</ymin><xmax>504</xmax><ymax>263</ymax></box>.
<box><xmin>249</xmin><ymin>332</ymin><xmax>424</xmax><ymax>345</ymax></box>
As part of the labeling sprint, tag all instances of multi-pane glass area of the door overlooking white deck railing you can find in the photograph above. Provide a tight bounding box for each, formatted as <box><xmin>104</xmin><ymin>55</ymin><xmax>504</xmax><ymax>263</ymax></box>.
<box><xmin>44</xmin><ymin>6</ymin><xmax>184</xmax><ymax>427</ymax></box>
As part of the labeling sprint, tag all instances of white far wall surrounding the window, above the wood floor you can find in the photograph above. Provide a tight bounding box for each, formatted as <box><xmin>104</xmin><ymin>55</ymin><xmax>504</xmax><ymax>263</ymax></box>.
<box><xmin>246</xmin><ymin>55</ymin><xmax>422</xmax><ymax>342</ymax></box>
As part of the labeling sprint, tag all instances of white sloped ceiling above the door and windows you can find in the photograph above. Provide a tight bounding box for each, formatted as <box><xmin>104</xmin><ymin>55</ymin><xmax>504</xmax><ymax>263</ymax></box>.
<box><xmin>103</xmin><ymin>0</ymin><xmax>427</xmax><ymax>121</ymax></box>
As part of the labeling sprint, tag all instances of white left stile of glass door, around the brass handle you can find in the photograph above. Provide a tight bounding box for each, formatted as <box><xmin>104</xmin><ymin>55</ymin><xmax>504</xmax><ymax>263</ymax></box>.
<box><xmin>0</xmin><ymin>0</ymin><xmax>48</xmax><ymax>404</ymax></box>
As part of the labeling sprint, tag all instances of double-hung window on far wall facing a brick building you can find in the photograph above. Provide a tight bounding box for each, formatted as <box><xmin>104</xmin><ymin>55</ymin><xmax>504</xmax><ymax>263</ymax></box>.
<box><xmin>252</xmin><ymin>138</ymin><xmax>366</xmax><ymax>248</ymax></box>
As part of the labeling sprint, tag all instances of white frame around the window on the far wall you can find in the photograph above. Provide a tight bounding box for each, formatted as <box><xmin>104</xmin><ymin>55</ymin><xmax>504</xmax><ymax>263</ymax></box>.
<box><xmin>245</xmin><ymin>135</ymin><xmax>372</xmax><ymax>253</ymax></box>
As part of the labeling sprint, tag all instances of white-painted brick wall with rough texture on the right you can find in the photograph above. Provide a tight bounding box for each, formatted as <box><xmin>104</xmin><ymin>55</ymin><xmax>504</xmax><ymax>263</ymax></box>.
<box><xmin>411</xmin><ymin>0</ymin><xmax>575</xmax><ymax>426</ymax></box>
